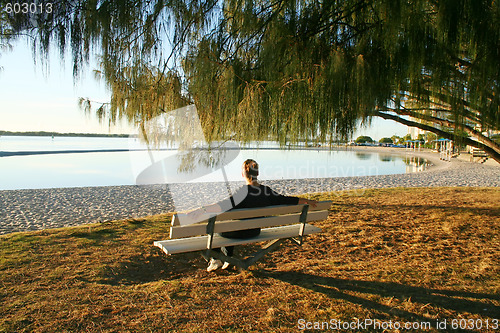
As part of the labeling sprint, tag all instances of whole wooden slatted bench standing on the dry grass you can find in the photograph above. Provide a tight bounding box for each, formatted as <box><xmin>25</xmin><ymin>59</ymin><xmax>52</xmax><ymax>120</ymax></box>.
<box><xmin>154</xmin><ymin>201</ymin><xmax>332</xmax><ymax>269</ymax></box>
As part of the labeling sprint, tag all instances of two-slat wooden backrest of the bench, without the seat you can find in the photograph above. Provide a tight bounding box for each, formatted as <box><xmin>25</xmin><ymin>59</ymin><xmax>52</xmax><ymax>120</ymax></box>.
<box><xmin>170</xmin><ymin>201</ymin><xmax>332</xmax><ymax>238</ymax></box>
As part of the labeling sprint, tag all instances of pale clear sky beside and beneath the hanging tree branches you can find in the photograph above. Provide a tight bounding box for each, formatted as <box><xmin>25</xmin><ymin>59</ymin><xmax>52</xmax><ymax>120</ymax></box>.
<box><xmin>0</xmin><ymin>41</ymin><xmax>408</xmax><ymax>140</ymax></box>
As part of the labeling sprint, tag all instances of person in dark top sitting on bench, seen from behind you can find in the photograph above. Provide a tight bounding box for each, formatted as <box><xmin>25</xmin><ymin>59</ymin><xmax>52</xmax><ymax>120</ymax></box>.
<box><xmin>189</xmin><ymin>159</ymin><xmax>317</xmax><ymax>272</ymax></box>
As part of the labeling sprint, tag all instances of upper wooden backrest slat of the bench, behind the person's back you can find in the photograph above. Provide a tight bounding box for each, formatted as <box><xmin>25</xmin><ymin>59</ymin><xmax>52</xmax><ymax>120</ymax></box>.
<box><xmin>172</xmin><ymin>201</ymin><xmax>332</xmax><ymax>226</ymax></box>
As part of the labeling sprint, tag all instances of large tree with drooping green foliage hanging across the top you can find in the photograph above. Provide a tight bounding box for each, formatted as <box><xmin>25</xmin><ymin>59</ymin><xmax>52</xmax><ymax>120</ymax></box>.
<box><xmin>3</xmin><ymin>0</ymin><xmax>500</xmax><ymax>162</ymax></box>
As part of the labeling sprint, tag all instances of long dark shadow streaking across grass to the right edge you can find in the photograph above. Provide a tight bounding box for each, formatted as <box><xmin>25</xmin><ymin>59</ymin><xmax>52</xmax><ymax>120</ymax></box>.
<box><xmin>260</xmin><ymin>271</ymin><xmax>500</xmax><ymax>321</ymax></box>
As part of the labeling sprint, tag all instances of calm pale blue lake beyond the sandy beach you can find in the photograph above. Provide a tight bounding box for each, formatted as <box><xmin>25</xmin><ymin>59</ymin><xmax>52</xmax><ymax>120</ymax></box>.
<box><xmin>0</xmin><ymin>136</ymin><xmax>426</xmax><ymax>190</ymax></box>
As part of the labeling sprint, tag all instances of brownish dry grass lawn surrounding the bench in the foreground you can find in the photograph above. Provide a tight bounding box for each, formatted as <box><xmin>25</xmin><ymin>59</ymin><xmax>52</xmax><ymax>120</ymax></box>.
<box><xmin>0</xmin><ymin>188</ymin><xmax>500</xmax><ymax>332</ymax></box>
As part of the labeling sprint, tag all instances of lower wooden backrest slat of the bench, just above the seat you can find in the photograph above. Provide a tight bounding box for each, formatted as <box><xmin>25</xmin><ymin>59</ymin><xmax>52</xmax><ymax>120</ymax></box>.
<box><xmin>170</xmin><ymin>210</ymin><xmax>328</xmax><ymax>239</ymax></box>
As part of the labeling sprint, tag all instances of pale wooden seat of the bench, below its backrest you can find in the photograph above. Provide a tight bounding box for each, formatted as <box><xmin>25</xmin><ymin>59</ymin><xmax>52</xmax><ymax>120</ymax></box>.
<box><xmin>154</xmin><ymin>224</ymin><xmax>321</xmax><ymax>254</ymax></box>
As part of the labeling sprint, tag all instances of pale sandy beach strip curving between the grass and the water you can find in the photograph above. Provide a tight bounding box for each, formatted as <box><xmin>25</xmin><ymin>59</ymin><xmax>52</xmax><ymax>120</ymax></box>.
<box><xmin>0</xmin><ymin>147</ymin><xmax>500</xmax><ymax>234</ymax></box>
